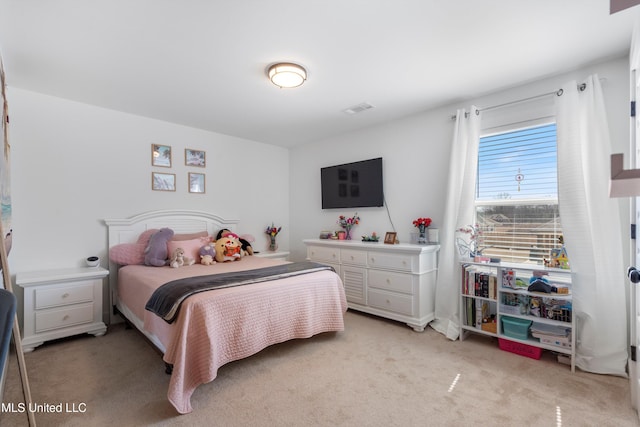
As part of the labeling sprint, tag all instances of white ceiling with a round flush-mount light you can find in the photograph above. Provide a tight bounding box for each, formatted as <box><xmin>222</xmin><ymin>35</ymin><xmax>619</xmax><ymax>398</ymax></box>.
<box><xmin>0</xmin><ymin>0</ymin><xmax>639</xmax><ymax>147</ymax></box>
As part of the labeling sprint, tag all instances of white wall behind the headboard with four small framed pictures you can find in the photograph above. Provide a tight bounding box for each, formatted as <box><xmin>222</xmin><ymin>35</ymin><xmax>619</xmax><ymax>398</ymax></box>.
<box><xmin>8</xmin><ymin>88</ymin><xmax>289</xmax><ymax>274</ymax></box>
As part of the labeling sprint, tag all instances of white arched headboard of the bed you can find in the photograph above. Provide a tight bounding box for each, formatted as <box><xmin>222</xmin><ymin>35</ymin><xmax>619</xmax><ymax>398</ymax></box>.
<box><xmin>104</xmin><ymin>209</ymin><xmax>238</xmax><ymax>320</ymax></box>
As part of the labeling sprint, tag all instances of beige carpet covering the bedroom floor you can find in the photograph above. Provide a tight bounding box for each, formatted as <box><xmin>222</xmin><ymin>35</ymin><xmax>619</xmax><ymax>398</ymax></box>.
<box><xmin>0</xmin><ymin>311</ymin><xmax>640</xmax><ymax>427</ymax></box>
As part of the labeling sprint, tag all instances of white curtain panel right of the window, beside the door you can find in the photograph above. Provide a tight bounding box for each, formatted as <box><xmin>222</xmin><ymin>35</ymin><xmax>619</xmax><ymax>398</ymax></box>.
<box><xmin>556</xmin><ymin>75</ymin><xmax>627</xmax><ymax>376</ymax></box>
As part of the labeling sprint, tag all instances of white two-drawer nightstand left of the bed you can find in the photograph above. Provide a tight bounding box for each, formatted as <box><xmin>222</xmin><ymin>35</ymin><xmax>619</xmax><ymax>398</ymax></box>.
<box><xmin>16</xmin><ymin>267</ymin><xmax>109</xmax><ymax>352</ymax></box>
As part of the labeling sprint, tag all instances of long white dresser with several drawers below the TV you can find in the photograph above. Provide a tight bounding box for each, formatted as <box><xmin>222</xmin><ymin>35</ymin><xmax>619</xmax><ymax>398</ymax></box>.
<box><xmin>304</xmin><ymin>239</ymin><xmax>440</xmax><ymax>332</ymax></box>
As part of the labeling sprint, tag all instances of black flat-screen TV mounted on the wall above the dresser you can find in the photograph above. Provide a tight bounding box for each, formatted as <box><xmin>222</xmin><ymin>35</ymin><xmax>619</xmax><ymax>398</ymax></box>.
<box><xmin>320</xmin><ymin>157</ymin><xmax>384</xmax><ymax>209</ymax></box>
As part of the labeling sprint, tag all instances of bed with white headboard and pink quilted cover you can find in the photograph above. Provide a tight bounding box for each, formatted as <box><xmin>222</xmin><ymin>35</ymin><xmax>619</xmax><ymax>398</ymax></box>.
<box><xmin>105</xmin><ymin>210</ymin><xmax>347</xmax><ymax>414</ymax></box>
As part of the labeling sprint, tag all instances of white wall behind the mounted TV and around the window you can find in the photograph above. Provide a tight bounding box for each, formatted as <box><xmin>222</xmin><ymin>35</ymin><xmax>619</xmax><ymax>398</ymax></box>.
<box><xmin>290</xmin><ymin>57</ymin><xmax>629</xmax><ymax>263</ymax></box>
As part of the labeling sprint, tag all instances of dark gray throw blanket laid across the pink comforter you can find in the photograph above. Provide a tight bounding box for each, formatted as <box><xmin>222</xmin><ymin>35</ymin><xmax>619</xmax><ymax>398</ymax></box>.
<box><xmin>145</xmin><ymin>261</ymin><xmax>335</xmax><ymax>323</ymax></box>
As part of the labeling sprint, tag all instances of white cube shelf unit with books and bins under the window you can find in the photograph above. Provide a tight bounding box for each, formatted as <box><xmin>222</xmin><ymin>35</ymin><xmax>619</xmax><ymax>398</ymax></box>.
<box><xmin>460</xmin><ymin>261</ymin><xmax>576</xmax><ymax>372</ymax></box>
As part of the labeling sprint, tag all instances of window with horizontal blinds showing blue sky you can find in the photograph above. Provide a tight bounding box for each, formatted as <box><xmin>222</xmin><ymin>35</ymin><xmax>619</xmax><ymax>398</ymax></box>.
<box><xmin>475</xmin><ymin>123</ymin><xmax>562</xmax><ymax>264</ymax></box>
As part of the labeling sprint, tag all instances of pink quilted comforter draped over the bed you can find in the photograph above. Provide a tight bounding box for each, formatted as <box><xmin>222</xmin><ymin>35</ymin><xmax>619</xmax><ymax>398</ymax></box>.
<box><xmin>118</xmin><ymin>256</ymin><xmax>347</xmax><ymax>414</ymax></box>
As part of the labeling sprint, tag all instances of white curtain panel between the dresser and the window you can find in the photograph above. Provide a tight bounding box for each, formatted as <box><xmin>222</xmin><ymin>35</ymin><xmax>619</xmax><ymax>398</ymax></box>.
<box><xmin>430</xmin><ymin>107</ymin><xmax>480</xmax><ymax>340</ymax></box>
